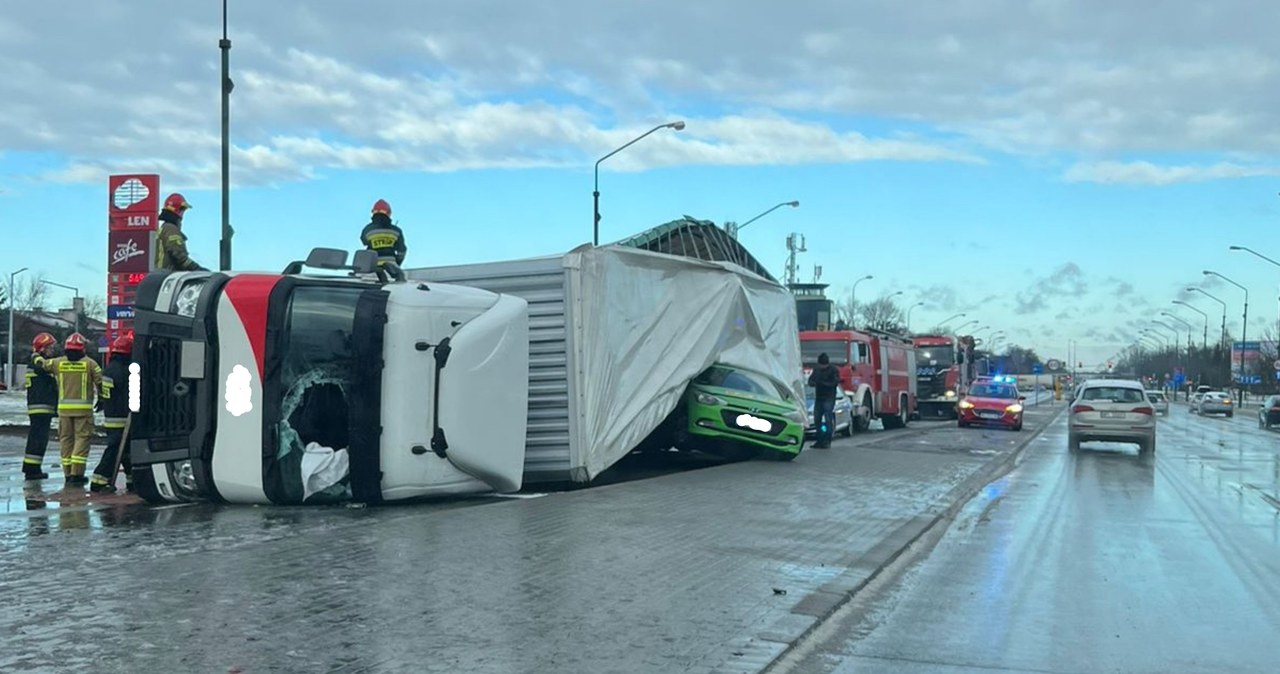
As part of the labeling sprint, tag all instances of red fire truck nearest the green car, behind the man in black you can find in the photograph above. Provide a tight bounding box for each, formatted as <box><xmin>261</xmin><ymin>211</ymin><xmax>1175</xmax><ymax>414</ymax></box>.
<box><xmin>800</xmin><ymin>329</ymin><xmax>915</xmax><ymax>431</ymax></box>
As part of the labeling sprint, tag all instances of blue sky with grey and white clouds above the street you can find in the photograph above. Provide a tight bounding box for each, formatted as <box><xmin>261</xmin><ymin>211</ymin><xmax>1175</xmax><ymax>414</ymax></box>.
<box><xmin>0</xmin><ymin>0</ymin><xmax>1280</xmax><ymax>362</ymax></box>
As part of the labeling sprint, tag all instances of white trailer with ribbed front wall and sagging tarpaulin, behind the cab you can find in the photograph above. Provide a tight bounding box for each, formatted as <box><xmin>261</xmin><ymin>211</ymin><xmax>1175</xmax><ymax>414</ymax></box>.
<box><xmin>406</xmin><ymin>246</ymin><xmax>804</xmax><ymax>483</ymax></box>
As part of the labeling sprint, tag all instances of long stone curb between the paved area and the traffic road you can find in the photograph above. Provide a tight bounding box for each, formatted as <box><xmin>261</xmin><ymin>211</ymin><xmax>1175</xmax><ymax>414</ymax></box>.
<box><xmin>747</xmin><ymin>405</ymin><xmax>1068</xmax><ymax>673</ymax></box>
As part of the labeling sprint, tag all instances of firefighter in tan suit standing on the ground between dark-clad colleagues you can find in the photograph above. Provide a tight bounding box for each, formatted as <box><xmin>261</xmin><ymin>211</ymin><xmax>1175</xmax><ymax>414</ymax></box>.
<box><xmin>41</xmin><ymin>333</ymin><xmax>102</xmax><ymax>486</ymax></box>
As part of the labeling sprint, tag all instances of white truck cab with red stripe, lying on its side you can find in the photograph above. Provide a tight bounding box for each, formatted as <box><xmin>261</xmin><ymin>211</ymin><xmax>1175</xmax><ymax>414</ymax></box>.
<box><xmin>128</xmin><ymin>248</ymin><xmax>529</xmax><ymax>504</ymax></box>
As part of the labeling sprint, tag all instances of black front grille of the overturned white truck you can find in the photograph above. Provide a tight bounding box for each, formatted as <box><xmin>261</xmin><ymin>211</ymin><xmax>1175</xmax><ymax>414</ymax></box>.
<box><xmin>138</xmin><ymin>336</ymin><xmax>196</xmax><ymax>439</ymax></box>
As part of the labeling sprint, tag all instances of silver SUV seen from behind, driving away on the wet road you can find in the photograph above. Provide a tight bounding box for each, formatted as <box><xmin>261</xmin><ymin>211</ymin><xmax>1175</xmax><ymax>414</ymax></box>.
<box><xmin>1066</xmin><ymin>379</ymin><xmax>1156</xmax><ymax>454</ymax></box>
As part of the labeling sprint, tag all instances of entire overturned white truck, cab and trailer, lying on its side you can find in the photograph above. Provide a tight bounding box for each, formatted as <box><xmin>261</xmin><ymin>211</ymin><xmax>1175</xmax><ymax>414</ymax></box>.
<box><xmin>129</xmin><ymin>220</ymin><xmax>803</xmax><ymax>504</ymax></box>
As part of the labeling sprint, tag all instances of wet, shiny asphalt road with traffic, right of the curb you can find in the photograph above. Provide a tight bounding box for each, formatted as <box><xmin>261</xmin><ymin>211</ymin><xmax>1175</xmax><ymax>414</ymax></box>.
<box><xmin>776</xmin><ymin>405</ymin><xmax>1280</xmax><ymax>674</ymax></box>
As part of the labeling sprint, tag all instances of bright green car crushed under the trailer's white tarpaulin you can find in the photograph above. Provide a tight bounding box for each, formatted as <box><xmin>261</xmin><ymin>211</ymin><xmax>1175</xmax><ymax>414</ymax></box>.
<box><xmin>675</xmin><ymin>364</ymin><xmax>809</xmax><ymax>460</ymax></box>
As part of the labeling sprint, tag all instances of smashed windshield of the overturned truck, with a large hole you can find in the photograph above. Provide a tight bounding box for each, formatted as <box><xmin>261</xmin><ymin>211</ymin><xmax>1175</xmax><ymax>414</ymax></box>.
<box><xmin>264</xmin><ymin>285</ymin><xmax>362</xmax><ymax>503</ymax></box>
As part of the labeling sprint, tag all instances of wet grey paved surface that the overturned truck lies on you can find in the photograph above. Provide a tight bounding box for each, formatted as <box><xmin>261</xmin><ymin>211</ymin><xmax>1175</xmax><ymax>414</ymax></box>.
<box><xmin>0</xmin><ymin>399</ymin><xmax>1051</xmax><ymax>674</ymax></box>
